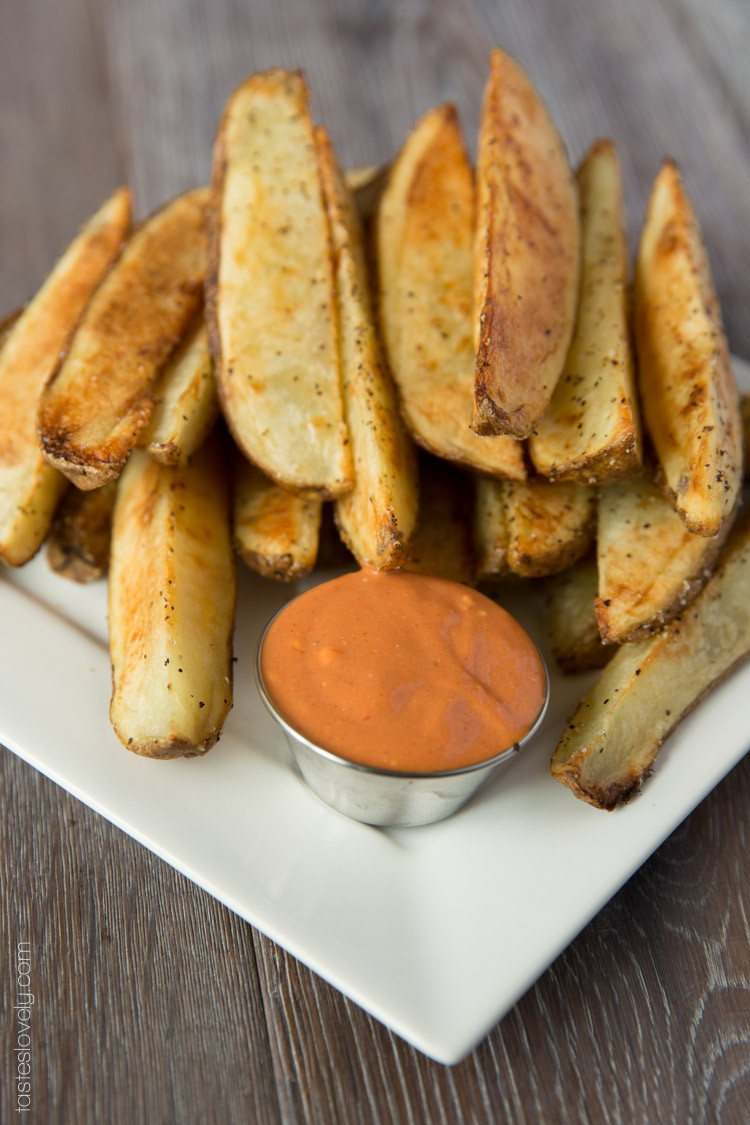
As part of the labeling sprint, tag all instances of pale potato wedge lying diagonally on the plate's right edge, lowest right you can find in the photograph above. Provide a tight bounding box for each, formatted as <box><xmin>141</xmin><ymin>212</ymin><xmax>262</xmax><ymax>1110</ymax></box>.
<box><xmin>551</xmin><ymin>516</ymin><xmax>750</xmax><ymax>809</ymax></box>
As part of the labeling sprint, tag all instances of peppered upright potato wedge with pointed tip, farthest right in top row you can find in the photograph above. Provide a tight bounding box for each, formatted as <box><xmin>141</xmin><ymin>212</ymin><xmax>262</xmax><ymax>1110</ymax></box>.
<box><xmin>634</xmin><ymin>160</ymin><xmax>742</xmax><ymax>536</ymax></box>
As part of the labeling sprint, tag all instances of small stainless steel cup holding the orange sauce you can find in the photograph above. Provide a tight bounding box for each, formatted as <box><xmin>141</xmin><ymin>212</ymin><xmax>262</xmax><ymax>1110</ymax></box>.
<box><xmin>255</xmin><ymin>610</ymin><xmax>550</xmax><ymax>828</ymax></box>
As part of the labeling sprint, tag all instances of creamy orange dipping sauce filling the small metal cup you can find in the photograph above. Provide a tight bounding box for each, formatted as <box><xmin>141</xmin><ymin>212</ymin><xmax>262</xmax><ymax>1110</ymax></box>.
<box><xmin>261</xmin><ymin>570</ymin><xmax>546</xmax><ymax>773</ymax></box>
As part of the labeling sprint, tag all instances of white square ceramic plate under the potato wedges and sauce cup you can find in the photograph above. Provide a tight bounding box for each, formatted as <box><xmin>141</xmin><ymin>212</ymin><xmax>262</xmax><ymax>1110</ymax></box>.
<box><xmin>0</xmin><ymin>355</ymin><xmax>750</xmax><ymax>1063</ymax></box>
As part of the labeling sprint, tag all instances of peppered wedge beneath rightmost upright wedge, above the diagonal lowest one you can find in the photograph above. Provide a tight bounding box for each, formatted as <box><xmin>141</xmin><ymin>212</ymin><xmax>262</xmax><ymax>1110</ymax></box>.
<box><xmin>596</xmin><ymin>479</ymin><xmax>730</xmax><ymax>644</ymax></box>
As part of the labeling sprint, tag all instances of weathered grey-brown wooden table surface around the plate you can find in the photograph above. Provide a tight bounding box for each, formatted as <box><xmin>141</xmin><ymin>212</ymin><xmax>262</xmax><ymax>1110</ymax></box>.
<box><xmin>0</xmin><ymin>0</ymin><xmax>750</xmax><ymax>1125</ymax></box>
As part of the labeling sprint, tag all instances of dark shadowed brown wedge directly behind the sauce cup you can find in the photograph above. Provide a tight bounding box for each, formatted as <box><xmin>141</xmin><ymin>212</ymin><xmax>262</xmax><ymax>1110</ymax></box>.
<box><xmin>404</xmin><ymin>453</ymin><xmax>476</xmax><ymax>586</ymax></box>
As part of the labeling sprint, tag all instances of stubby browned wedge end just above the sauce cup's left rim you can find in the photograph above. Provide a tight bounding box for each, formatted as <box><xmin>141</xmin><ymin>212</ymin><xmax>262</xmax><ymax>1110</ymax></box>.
<box><xmin>234</xmin><ymin>453</ymin><xmax>323</xmax><ymax>582</ymax></box>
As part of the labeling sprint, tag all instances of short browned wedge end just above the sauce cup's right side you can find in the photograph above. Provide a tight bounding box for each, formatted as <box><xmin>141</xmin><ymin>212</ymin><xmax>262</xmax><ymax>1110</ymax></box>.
<box><xmin>504</xmin><ymin>477</ymin><xmax>596</xmax><ymax>578</ymax></box>
